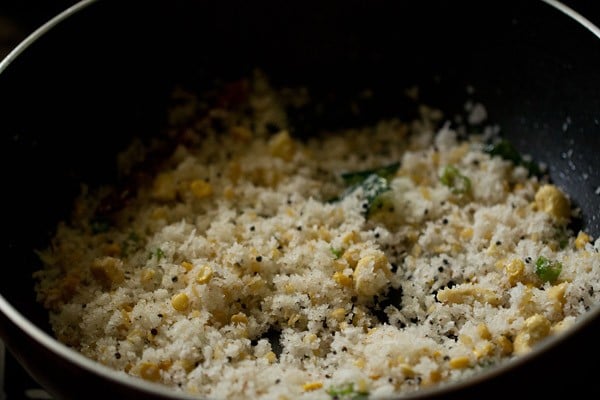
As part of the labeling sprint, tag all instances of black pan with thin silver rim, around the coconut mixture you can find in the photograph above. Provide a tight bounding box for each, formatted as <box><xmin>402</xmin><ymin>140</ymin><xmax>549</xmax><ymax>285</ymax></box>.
<box><xmin>0</xmin><ymin>0</ymin><xmax>600</xmax><ymax>399</ymax></box>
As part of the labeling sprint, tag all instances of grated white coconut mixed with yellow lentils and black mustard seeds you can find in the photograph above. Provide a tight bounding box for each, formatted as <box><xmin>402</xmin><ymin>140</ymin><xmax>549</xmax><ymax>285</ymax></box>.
<box><xmin>35</xmin><ymin>75</ymin><xmax>600</xmax><ymax>399</ymax></box>
